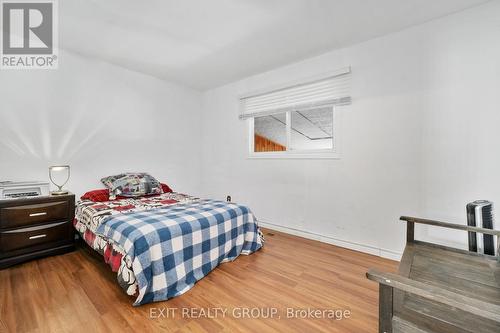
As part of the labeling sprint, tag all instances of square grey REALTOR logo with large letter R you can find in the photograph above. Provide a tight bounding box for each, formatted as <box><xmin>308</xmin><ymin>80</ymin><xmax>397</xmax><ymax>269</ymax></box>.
<box><xmin>0</xmin><ymin>0</ymin><xmax>58</xmax><ymax>69</ymax></box>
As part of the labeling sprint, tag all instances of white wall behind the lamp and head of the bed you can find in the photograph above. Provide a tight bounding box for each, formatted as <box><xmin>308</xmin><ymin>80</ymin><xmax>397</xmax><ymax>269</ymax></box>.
<box><xmin>0</xmin><ymin>52</ymin><xmax>201</xmax><ymax>195</ymax></box>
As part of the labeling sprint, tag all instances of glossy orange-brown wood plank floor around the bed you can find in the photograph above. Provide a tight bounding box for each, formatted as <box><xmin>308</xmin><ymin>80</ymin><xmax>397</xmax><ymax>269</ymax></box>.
<box><xmin>0</xmin><ymin>230</ymin><xmax>397</xmax><ymax>332</ymax></box>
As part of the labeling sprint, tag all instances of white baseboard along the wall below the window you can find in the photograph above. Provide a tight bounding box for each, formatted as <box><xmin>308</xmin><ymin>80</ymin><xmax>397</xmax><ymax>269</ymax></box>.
<box><xmin>258</xmin><ymin>220</ymin><xmax>403</xmax><ymax>261</ymax></box>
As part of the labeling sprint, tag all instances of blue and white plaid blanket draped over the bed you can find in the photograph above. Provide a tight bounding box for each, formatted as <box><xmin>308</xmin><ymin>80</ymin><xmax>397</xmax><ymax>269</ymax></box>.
<box><xmin>96</xmin><ymin>200</ymin><xmax>263</xmax><ymax>305</ymax></box>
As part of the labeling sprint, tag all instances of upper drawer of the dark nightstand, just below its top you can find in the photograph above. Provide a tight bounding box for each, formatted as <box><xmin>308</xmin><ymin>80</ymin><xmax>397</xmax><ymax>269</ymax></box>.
<box><xmin>0</xmin><ymin>201</ymin><xmax>69</xmax><ymax>229</ymax></box>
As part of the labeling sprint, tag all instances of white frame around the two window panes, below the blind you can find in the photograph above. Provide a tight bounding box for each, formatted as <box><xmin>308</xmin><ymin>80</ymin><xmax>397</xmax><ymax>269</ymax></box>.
<box><xmin>247</xmin><ymin>104</ymin><xmax>341</xmax><ymax>159</ymax></box>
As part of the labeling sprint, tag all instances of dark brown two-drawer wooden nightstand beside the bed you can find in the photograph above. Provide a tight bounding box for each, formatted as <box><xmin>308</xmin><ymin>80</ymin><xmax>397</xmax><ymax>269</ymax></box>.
<box><xmin>0</xmin><ymin>193</ymin><xmax>75</xmax><ymax>269</ymax></box>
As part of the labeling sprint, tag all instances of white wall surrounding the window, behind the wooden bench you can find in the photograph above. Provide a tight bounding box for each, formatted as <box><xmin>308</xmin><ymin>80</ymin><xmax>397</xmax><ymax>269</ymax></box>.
<box><xmin>202</xmin><ymin>1</ymin><xmax>500</xmax><ymax>257</ymax></box>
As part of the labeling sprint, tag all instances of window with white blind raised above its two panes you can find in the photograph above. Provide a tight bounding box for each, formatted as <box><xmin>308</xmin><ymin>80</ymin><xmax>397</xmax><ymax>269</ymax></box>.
<box><xmin>240</xmin><ymin>68</ymin><xmax>351</xmax><ymax>158</ymax></box>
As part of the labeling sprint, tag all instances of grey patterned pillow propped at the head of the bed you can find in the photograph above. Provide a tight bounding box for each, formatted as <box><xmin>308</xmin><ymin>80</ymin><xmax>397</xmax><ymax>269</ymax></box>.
<box><xmin>101</xmin><ymin>173</ymin><xmax>163</xmax><ymax>200</ymax></box>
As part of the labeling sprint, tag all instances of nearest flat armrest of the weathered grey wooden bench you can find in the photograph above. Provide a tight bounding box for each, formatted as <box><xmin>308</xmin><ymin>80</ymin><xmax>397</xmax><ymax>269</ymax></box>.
<box><xmin>366</xmin><ymin>269</ymin><xmax>500</xmax><ymax>323</ymax></box>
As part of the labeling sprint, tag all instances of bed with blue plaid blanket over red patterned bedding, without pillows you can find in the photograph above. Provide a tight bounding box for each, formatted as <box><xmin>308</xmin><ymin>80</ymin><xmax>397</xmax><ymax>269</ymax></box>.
<box><xmin>74</xmin><ymin>192</ymin><xmax>264</xmax><ymax>306</ymax></box>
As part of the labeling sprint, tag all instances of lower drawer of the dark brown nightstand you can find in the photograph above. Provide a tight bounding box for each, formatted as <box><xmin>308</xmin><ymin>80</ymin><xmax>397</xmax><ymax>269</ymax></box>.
<box><xmin>0</xmin><ymin>222</ymin><xmax>71</xmax><ymax>252</ymax></box>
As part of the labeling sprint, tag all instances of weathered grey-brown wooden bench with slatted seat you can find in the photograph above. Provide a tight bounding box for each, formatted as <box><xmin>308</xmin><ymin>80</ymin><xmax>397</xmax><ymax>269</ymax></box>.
<box><xmin>366</xmin><ymin>216</ymin><xmax>500</xmax><ymax>333</ymax></box>
